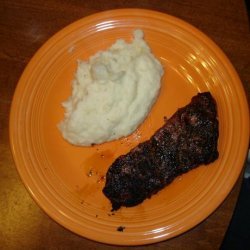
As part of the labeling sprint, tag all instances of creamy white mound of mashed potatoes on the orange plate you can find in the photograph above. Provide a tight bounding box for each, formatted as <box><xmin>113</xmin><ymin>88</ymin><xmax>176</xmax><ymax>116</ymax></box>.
<box><xmin>59</xmin><ymin>30</ymin><xmax>163</xmax><ymax>146</ymax></box>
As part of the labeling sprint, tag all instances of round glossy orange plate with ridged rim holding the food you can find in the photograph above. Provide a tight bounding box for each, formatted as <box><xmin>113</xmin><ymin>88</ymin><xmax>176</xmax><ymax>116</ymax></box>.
<box><xmin>10</xmin><ymin>9</ymin><xmax>249</xmax><ymax>245</ymax></box>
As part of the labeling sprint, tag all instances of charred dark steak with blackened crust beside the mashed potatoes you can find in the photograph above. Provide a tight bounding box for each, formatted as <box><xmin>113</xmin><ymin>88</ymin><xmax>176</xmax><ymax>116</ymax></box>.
<box><xmin>103</xmin><ymin>92</ymin><xmax>219</xmax><ymax>210</ymax></box>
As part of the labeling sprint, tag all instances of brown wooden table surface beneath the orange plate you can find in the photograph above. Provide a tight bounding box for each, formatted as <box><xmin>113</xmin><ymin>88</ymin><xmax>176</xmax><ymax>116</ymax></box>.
<box><xmin>0</xmin><ymin>0</ymin><xmax>250</xmax><ymax>250</ymax></box>
